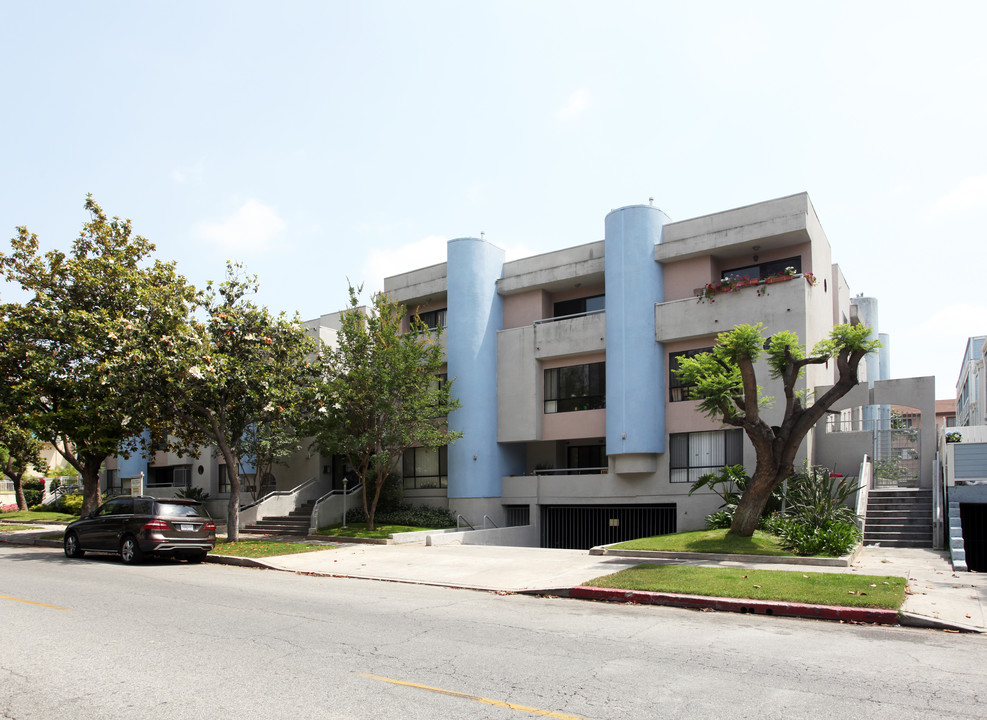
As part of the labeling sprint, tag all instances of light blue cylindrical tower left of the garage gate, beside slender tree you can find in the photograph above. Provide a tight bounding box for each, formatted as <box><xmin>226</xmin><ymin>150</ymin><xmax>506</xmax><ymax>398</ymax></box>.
<box><xmin>446</xmin><ymin>238</ymin><xmax>524</xmax><ymax>498</ymax></box>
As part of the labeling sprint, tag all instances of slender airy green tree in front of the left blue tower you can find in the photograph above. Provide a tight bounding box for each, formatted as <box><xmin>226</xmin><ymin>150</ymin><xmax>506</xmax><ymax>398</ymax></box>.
<box><xmin>313</xmin><ymin>286</ymin><xmax>462</xmax><ymax>530</ymax></box>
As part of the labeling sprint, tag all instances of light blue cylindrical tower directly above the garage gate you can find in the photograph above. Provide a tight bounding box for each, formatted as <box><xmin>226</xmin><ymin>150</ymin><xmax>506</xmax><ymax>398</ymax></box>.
<box><xmin>604</xmin><ymin>205</ymin><xmax>668</xmax><ymax>455</ymax></box>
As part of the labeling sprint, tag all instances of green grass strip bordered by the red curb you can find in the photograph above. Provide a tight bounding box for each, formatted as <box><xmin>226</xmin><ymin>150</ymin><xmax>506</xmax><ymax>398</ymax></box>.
<box><xmin>583</xmin><ymin>564</ymin><xmax>906</xmax><ymax>610</ymax></box>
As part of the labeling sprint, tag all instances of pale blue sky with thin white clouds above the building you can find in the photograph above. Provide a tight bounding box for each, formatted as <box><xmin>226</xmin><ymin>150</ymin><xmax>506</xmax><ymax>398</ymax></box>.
<box><xmin>0</xmin><ymin>0</ymin><xmax>987</xmax><ymax>397</ymax></box>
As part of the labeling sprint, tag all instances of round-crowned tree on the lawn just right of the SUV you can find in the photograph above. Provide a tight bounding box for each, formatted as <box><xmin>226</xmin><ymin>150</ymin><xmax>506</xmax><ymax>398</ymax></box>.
<box><xmin>150</xmin><ymin>264</ymin><xmax>316</xmax><ymax>542</ymax></box>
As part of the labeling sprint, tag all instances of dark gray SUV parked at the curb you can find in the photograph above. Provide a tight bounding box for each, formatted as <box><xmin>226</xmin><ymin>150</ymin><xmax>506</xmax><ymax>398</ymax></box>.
<box><xmin>64</xmin><ymin>497</ymin><xmax>216</xmax><ymax>563</ymax></box>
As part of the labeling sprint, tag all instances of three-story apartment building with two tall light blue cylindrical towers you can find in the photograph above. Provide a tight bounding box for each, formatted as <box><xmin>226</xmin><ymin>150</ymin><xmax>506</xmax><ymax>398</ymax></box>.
<box><xmin>384</xmin><ymin>193</ymin><xmax>900</xmax><ymax>547</ymax></box>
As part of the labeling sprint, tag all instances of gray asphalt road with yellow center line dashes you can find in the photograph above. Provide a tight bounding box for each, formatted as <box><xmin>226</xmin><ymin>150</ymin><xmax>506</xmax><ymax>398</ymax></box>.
<box><xmin>0</xmin><ymin>547</ymin><xmax>987</xmax><ymax>720</ymax></box>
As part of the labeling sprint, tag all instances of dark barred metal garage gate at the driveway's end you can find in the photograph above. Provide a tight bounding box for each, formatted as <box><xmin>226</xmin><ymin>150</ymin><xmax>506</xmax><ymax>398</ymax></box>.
<box><xmin>541</xmin><ymin>503</ymin><xmax>676</xmax><ymax>550</ymax></box>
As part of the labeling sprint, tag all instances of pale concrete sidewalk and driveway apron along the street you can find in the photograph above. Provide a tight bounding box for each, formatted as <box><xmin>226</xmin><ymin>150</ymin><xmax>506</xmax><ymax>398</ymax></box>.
<box><xmin>0</xmin><ymin>525</ymin><xmax>987</xmax><ymax>632</ymax></box>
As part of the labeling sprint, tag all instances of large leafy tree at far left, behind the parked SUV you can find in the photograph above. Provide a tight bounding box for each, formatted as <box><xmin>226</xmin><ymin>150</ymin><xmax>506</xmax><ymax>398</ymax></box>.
<box><xmin>0</xmin><ymin>196</ymin><xmax>195</xmax><ymax>514</ymax></box>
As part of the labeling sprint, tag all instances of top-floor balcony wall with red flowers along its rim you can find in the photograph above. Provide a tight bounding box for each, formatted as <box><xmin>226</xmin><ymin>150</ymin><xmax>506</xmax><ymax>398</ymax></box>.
<box><xmin>655</xmin><ymin>275</ymin><xmax>812</xmax><ymax>342</ymax></box>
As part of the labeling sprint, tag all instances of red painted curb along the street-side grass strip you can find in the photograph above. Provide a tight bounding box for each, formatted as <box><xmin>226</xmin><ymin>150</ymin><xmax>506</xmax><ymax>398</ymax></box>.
<box><xmin>569</xmin><ymin>586</ymin><xmax>899</xmax><ymax>625</ymax></box>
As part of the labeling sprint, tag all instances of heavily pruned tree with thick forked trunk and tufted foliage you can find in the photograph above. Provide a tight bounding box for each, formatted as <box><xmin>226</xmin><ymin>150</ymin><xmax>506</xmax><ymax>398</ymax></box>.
<box><xmin>676</xmin><ymin>323</ymin><xmax>880</xmax><ymax>537</ymax></box>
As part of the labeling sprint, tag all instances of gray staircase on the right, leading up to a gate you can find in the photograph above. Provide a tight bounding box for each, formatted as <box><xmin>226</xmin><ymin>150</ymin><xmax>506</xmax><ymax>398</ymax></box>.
<box><xmin>864</xmin><ymin>488</ymin><xmax>932</xmax><ymax>548</ymax></box>
